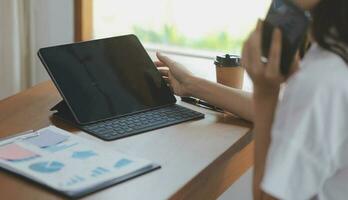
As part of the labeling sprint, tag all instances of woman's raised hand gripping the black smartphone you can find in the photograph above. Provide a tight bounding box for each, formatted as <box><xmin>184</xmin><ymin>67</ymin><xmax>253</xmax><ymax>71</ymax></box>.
<box><xmin>242</xmin><ymin>21</ymin><xmax>286</xmax><ymax>95</ymax></box>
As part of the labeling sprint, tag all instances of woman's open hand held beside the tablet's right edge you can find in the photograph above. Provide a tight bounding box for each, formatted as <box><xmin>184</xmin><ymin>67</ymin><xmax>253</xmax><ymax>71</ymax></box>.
<box><xmin>155</xmin><ymin>53</ymin><xmax>195</xmax><ymax>96</ymax></box>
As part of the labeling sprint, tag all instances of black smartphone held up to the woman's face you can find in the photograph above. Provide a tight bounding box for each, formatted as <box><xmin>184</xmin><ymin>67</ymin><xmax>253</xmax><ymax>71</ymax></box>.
<box><xmin>262</xmin><ymin>0</ymin><xmax>310</xmax><ymax>76</ymax></box>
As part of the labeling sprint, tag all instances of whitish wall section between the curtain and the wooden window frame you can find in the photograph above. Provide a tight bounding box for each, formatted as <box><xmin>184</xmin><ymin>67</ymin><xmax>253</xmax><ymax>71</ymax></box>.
<box><xmin>31</xmin><ymin>0</ymin><xmax>74</xmax><ymax>85</ymax></box>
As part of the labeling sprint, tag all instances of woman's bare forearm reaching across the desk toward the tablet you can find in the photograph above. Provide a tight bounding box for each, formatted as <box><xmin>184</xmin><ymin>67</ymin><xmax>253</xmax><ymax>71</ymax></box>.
<box><xmin>189</xmin><ymin>78</ymin><xmax>253</xmax><ymax>121</ymax></box>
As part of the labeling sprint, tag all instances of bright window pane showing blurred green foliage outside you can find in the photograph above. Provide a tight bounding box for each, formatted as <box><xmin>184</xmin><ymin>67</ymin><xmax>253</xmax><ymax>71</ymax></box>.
<box><xmin>93</xmin><ymin>0</ymin><xmax>271</xmax><ymax>54</ymax></box>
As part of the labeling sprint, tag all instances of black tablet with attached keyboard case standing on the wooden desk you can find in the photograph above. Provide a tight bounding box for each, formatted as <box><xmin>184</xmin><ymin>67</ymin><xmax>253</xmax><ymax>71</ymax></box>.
<box><xmin>38</xmin><ymin>35</ymin><xmax>204</xmax><ymax>140</ymax></box>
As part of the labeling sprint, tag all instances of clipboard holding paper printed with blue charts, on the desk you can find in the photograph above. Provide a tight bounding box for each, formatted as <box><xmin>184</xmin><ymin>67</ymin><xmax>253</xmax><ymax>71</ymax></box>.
<box><xmin>0</xmin><ymin>126</ymin><xmax>159</xmax><ymax>198</ymax></box>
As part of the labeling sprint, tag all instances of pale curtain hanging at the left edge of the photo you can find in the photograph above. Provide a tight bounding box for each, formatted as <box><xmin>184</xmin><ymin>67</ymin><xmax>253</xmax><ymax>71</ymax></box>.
<box><xmin>0</xmin><ymin>0</ymin><xmax>32</xmax><ymax>99</ymax></box>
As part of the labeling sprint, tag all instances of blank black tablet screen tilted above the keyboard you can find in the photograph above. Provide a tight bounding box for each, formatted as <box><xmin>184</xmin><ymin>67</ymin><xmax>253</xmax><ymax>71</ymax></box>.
<box><xmin>39</xmin><ymin>35</ymin><xmax>175</xmax><ymax>124</ymax></box>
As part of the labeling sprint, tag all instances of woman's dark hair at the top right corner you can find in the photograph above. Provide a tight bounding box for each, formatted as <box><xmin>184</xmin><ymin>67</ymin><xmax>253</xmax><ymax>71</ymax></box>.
<box><xmin>311</xmin><ymin>0</ymin><xmax>348</xmax><ymax>64</ymax></box>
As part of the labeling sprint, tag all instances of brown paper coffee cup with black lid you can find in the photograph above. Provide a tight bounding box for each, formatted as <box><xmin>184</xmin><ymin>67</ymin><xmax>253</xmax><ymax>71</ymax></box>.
<box><xmin>214</xmin><ymin>54</ymin><xmax>244</xmax><ymax>89</ymax></box>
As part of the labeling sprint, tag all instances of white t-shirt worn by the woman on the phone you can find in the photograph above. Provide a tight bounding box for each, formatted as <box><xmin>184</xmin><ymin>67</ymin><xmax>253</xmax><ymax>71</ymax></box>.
<box><xmin>261</xmin><ymin>44</ymin><xmax>348</xmax><ymax>200</ymax></box>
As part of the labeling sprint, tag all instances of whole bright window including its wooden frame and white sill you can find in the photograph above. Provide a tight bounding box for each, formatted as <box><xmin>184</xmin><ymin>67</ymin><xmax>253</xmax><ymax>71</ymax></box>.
<box><xmin>75</xmin><ymin>0</ymin><xmax>272</xmax><ymax>91</ymax></box>
